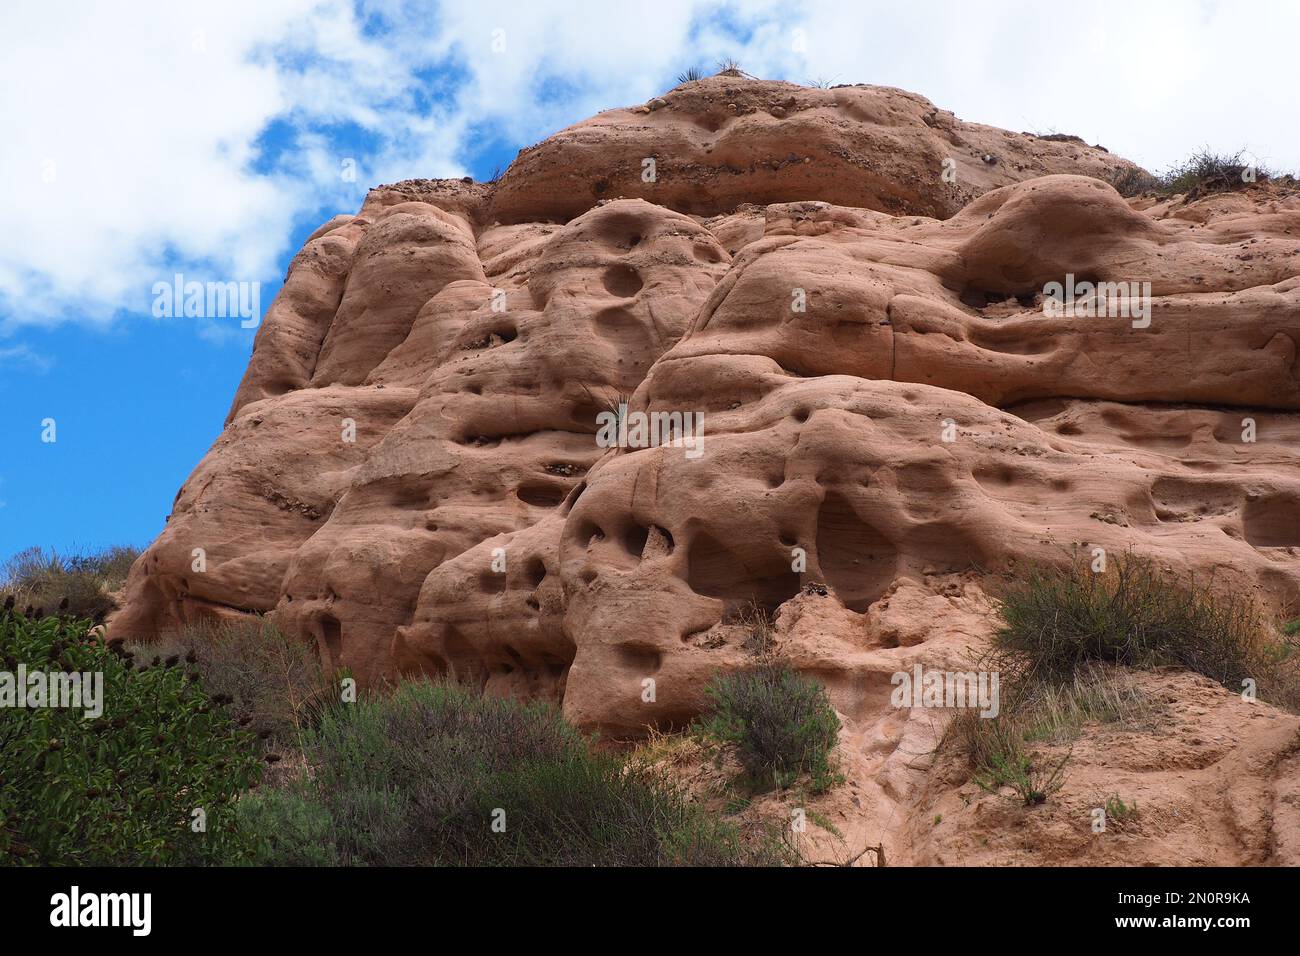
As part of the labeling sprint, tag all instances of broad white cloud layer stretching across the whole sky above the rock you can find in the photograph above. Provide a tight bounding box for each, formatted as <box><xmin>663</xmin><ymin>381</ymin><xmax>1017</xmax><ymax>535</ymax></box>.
<box><xmin>0</xmin><ymin>0</ymin><xmax>1300</xmax><ymax>332</ymax></box>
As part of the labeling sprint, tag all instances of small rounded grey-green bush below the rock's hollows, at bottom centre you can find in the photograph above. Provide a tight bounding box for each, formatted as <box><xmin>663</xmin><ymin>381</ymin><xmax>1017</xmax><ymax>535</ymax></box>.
<box><xmin>697</xmin><ymin>662</ymin><xmax>840</xmax><ymax>792</ymax></box>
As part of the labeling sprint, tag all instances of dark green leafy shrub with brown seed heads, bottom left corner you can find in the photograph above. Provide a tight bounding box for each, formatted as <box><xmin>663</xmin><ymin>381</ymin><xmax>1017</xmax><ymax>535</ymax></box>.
<box><xmin>0</xmin><ymin>609</ymin><xmax>261</xmax><ymax>866</ymax></box>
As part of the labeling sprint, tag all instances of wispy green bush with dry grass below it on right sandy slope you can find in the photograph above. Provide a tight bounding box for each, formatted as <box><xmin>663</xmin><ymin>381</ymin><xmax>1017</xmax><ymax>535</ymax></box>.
<box><xmin>948</xmin><ymin>555</ymin><xmax>1300</xmax><ymax>805</ymax></box>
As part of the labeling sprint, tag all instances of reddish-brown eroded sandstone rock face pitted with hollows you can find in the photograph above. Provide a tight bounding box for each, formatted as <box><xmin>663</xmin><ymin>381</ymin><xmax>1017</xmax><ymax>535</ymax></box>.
<box><xmin>111</xmin><ymin>77</ymin><xmax>1300</xmax><ymax>749</ymax></box>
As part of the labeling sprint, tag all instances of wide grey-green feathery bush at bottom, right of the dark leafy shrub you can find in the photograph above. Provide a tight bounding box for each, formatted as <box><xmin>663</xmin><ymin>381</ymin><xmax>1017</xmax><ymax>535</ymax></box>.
<box><xmin>239</xmin><ymin>682</ymin><xmax>785</xmax><ymax>866</ymax></box>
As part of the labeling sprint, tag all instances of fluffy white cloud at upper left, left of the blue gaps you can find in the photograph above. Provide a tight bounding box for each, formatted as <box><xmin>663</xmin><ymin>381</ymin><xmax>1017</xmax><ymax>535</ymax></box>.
<box><xmin>0</xmin><ymin>0</ymin><xmax>421</xmax><ymax>325</ymax></box>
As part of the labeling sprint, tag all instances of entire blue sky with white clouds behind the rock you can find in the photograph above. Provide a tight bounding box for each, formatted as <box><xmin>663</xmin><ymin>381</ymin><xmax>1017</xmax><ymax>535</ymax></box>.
<box><xmin>0</xmin><ymin>0</ymin><xmax>1300</xmax><ymax>561</ymax></box>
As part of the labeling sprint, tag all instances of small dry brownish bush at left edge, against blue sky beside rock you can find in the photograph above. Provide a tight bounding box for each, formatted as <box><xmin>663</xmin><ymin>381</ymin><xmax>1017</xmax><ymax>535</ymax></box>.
<box><xmin>0</xmin><ymin>548</ymin><xmax>140</xmax><ymax>623</ymax></box>
